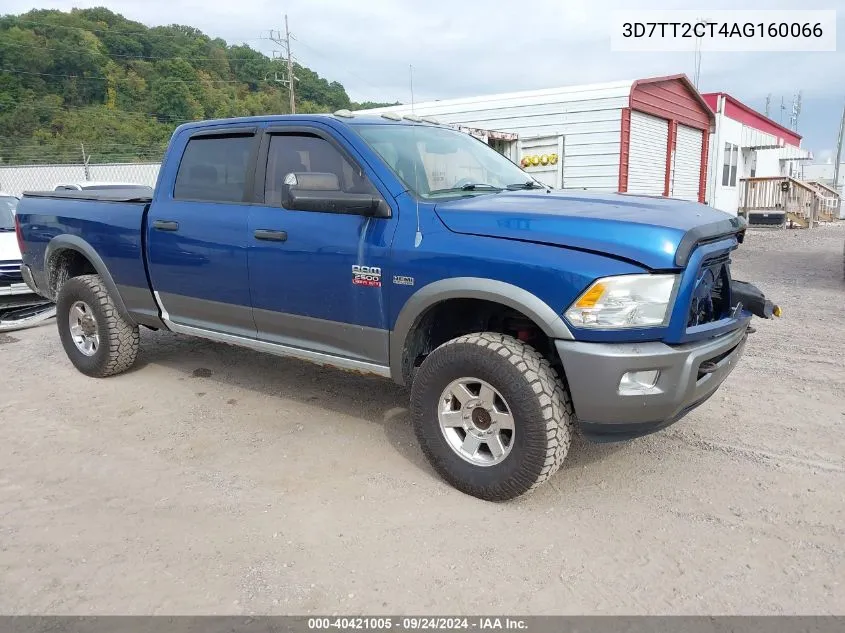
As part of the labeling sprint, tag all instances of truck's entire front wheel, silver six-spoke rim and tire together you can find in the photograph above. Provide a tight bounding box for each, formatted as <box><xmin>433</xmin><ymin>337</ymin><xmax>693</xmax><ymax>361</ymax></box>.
<box><xmin>411</xmin><ymin>332</ymin><xmax>574</xmax><ymax>501</ymax></box>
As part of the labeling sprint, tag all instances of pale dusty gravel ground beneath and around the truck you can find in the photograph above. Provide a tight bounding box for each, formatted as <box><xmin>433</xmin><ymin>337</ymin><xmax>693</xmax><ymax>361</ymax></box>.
<box><xmin>0</xmin><ymin>226</ymin><xmax>845</xmax><ymax>615</ymax></box>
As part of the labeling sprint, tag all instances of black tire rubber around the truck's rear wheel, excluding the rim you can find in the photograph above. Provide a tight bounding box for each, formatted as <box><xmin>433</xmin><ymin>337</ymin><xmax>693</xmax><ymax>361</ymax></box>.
<box><xmin>56</xmin><ymin>275</ymin><xmax>141</xmax><ymax>378</ymax></box>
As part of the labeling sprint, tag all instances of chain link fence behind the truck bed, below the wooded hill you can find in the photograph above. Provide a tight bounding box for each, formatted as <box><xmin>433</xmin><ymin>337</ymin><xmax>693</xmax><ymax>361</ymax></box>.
<box><xmin>0</xmin><ymin>162</ymin><xmax>161</xmax><ymax>197</ymax></box>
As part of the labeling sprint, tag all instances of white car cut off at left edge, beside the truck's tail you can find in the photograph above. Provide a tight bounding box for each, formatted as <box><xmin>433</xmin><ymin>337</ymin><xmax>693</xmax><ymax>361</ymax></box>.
<box><xmin>0</xmin><ymin>191</ymin><xmax>55</xmax><ymax>332</ymax></box>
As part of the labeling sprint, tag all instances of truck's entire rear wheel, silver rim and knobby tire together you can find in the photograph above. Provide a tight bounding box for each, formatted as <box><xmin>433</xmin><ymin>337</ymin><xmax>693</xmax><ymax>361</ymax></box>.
<box><xmin>56</xmin><ymin>275</ymin><xmax>140</xmax><ymax>378</ymax></box>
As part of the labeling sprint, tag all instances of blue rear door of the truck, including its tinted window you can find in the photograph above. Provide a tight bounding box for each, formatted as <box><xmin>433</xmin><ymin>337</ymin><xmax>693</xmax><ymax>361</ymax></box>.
<box><xmin>147</xmin><ymin>126</ymin><xmax>258</xmax><ymax>338</ymax></box>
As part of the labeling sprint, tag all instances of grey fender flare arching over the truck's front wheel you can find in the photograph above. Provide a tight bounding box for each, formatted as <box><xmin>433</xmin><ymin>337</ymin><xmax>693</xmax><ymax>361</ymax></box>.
<box><xmin>390</xmin><ymin>277</ymin><xmax>574</xmax><ymax>385</ymax></box>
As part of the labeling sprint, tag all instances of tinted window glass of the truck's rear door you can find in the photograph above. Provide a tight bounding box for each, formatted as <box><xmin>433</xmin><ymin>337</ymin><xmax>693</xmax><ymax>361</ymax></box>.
<box><xmin>173</xmin><ymin>136</ymin><xmax>254</xmax><ymax>202</ymax></box>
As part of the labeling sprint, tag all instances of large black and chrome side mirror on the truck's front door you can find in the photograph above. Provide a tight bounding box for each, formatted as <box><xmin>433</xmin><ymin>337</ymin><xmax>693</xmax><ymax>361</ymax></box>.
<box><xmin>282</xmin><ymin>172</ymin><xmax>390</xmax><ymax>218</ymax></box>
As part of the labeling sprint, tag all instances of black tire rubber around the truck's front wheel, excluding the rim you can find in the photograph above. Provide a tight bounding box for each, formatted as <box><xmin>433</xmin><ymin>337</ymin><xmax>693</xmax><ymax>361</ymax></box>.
<box><xmin>411</xmin><ymin>332</ymin><xmax>575</xmax><ymax>501</ymax></box>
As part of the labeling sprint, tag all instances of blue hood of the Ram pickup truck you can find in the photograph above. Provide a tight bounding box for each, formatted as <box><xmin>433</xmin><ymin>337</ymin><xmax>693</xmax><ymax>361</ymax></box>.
<box><xmin>435</xmin><ymin>190</ymin><xmax>745</xmax><ymax>269</ymax></box>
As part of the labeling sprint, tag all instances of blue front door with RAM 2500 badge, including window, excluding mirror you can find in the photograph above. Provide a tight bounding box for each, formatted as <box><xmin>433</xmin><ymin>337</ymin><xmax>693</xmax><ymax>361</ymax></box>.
<box><xmin>249</xmin><ymin>124</ymin><xmax>396</xmax><ymax>365</ymax></box>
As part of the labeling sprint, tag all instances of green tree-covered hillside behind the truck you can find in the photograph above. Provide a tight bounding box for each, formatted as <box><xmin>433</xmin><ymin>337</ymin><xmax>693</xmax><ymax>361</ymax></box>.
<box><xmin>0</xmin><ymin>8</ymin><xmax>398</xmax><ymax>164</ymax></box>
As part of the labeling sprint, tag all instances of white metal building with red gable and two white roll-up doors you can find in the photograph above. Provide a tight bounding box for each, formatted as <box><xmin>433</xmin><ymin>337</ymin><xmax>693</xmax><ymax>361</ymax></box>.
<box><xmin>356</xmin><ymin>75</ymin><xmax>713</xmax><ymax>201</ymax></box>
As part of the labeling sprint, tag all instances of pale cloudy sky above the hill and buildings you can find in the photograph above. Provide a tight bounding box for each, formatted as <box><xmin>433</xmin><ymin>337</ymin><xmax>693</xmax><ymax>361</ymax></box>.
<box><xmin>0</xmin><ymin>0</ymin><xmax>845</xmax><ymax>162</ymax></box>
